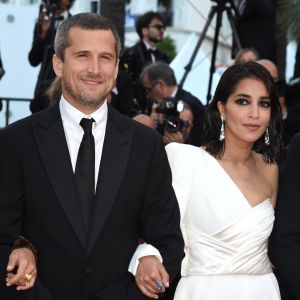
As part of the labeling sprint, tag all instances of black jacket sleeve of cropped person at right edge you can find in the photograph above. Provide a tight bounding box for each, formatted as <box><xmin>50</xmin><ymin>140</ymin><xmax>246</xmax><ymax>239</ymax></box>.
<box><xmin>269</xmin><ymin>134</ymin><xmax>300</xmax><ymax>300</ymax></box>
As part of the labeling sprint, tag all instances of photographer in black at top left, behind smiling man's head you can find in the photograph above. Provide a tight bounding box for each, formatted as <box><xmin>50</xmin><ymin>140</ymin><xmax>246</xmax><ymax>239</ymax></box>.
<box><xmin>28</xmin><ymin>0</ymin><xmax>74</xmax><ymax>113</ymax></box>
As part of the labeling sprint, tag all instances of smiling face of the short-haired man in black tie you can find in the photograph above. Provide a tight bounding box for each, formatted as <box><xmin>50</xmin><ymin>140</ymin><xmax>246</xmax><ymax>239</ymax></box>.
<box><xmin>53</xmin><ymin>27</ymin><xmax>118</xmax><ymax>113</ymax></box>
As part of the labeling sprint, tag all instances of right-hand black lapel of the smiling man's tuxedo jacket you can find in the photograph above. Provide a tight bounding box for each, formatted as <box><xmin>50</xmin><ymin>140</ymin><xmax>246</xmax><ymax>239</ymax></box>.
<box><xmin>86</xmin><ymin>106</ymin><xmax>132</xmax><ymax>256</ymax></box>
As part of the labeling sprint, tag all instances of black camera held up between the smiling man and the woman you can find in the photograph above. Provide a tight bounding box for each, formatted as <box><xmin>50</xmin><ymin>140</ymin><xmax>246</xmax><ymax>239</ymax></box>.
<box><xmin>156</xmin><ymin>97</ymin><xmax>185</xmax><ymax>134</ymax></box>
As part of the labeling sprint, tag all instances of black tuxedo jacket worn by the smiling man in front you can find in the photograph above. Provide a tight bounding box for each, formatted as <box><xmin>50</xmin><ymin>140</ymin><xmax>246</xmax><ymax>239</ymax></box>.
<box><xmin>0</xmin><ymin>104</ymin><xmax>183</xmax><ymax>300</ymax></box>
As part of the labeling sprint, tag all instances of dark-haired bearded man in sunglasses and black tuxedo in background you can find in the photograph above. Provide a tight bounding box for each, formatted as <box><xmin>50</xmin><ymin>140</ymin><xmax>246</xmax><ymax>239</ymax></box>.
<box><xmin>120</xmin><ymin>11</ymin><xmax>169</xmax><ymax>112</ymax></box>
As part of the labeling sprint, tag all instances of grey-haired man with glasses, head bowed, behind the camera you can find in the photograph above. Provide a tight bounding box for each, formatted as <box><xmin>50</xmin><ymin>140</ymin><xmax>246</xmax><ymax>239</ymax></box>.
<box><xmin>140</xmin><ymin>62</ymin><xmax>205</xmax><ymax>146</ymax></box>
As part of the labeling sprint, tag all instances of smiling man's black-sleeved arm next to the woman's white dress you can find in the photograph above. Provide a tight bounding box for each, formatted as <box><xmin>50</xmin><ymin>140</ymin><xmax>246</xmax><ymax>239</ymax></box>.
<box><xmin>141</xmin><ymin>136</ymin><xmax>184</xmax><ymax>281</ymax></box>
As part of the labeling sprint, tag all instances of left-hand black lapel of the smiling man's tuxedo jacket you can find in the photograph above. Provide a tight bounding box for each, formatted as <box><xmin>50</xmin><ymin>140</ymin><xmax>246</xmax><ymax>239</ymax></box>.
<box><xmin>34</xmin><ymin>104</ymin><xmax>86</xmax><ymax>246</ymax></box>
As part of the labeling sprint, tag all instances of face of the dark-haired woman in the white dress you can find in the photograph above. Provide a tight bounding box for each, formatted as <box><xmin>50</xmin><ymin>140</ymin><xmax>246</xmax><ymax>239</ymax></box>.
<box><xmin>218</xmin><ymin>78</ymin><xmax>271</xmax><ymax>143</ymax></box>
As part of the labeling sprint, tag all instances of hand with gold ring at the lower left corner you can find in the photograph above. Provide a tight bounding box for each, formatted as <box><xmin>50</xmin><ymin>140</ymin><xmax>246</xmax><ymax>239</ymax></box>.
<box><xmin>6</xmin><ymin>248</ymin><xmax>37</xmax><ymax>291</ymax></box>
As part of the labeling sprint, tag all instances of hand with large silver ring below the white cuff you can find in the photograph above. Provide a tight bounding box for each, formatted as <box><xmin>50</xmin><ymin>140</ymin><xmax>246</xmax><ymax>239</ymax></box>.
<box><xmin>135</xmin><ymin>255</ymin><xmax>169</xmax><ymax>299</ymax></box>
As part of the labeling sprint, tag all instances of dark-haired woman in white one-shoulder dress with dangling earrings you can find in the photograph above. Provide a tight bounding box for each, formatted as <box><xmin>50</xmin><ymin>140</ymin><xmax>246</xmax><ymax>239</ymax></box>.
<box><xmin>166</xmin><ymin>62</ymin><xmax>283</xmax><ymax>300</ymax></box>
